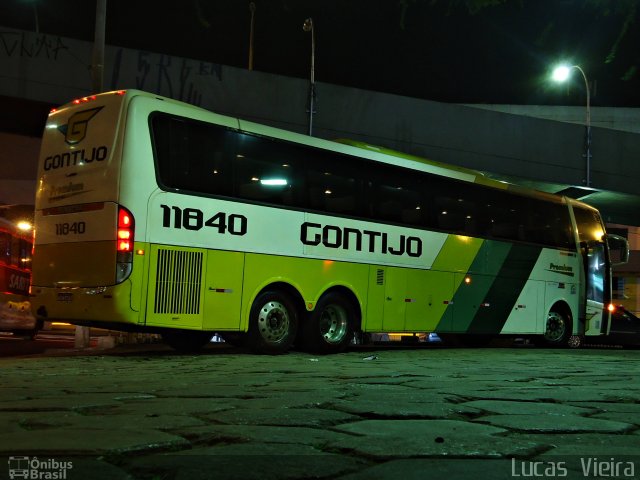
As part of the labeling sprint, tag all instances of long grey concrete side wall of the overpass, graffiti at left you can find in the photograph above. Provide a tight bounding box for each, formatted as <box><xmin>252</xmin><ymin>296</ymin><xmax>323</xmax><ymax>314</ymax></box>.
<box><xmin>0</xmin><ymin>27</ymin><xmax>640</xmax><ymax>202</ymax></box>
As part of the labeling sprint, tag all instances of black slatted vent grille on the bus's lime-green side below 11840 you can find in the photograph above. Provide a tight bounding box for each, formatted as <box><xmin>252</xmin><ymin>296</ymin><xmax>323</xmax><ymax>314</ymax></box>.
<box><xmin>153</xmin><ymin>249</ymin><xmax>203</xmax><ymax>315</ymax></box>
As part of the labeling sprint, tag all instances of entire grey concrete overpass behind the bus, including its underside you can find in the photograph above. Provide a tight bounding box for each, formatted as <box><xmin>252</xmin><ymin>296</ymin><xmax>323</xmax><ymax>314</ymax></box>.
<box><xmin>0</xmin><ymin>27</ymin><xmax>640</xmax><ymax>226</ymax></box>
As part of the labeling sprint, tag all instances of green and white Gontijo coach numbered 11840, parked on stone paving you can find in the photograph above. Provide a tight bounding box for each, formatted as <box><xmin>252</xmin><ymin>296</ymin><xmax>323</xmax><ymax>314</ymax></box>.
<box><xmin>32</xmin><ymin>90</ymin><xmax>632</xmax><ymax>353</ymax></box>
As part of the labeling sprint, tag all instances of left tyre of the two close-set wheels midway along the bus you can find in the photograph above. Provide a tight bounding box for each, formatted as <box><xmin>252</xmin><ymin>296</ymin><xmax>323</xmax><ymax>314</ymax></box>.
<box><xmin>247</xmin><ymin>290</ymin><xmax>298</xmax><ymax>355</ymax></box>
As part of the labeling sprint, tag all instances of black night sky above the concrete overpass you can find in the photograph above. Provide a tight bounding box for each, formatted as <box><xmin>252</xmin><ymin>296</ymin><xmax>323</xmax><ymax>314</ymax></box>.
<box><xmin>0</xmin><ymin>0</ymin><xmax>640</xmax><ymax>107</ymax></box>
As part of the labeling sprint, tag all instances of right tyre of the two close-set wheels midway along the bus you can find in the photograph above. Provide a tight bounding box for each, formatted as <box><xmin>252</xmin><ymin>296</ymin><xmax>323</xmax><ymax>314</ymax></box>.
<box><xmin>301</xmin><ymin>292</ymin><xmax>356</xmax><ymax>353</ymax></box>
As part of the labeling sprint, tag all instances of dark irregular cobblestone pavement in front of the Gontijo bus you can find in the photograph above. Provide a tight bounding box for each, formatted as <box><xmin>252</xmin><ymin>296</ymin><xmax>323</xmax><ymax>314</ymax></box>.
<box><xmin>0</xmin><ymin>345</ymin><xmax>640</xmax><ymax>480</ymax></box>
